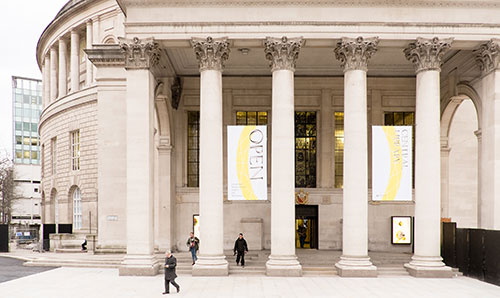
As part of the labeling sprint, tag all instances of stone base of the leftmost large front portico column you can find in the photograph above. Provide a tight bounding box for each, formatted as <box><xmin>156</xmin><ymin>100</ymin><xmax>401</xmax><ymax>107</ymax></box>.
<box><xmin>118</xmin><ymin>255</ymin><xmax>161</xmax><ymax>276</ymax></box>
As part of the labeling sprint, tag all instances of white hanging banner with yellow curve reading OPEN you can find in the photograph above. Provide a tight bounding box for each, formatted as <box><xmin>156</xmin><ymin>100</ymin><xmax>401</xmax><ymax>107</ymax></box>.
<box><xmin>227</xmin><ymin>125</ymin><xmax>267</xmax><ymax>200</ymax></box>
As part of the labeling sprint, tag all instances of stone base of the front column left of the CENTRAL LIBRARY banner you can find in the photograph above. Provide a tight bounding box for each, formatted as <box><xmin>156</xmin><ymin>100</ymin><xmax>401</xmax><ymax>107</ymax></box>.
<box><xmin>335</xmin><ymin>256</ymin><xmax>377</xmax><ymax>277</ymax></box>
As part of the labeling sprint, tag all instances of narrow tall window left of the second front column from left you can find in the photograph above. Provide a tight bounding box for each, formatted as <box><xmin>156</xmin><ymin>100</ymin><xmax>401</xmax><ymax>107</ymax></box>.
<box><xmin>187</xmin><ymin>111</ymin><xmax>200</xmax><ymax>187</ymax></box>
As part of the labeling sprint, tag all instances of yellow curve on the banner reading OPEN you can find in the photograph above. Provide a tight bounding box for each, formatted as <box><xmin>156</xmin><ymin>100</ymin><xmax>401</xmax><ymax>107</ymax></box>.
<box><xmin>236</xmin><ymin>125</ymin><xmax>258</xmax><ymax>200</ymax></box>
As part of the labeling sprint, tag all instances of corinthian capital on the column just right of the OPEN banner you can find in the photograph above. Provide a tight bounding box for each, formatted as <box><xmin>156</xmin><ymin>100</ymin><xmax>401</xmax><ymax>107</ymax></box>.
<box><xmin>264</xmin><ymin>36</ymin><xmax>304</xmax><ymax>71</ymax></box>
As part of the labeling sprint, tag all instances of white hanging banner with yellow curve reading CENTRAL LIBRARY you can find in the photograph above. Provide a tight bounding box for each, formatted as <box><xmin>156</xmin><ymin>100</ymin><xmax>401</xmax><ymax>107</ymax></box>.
<box><xmin>372</xmin><ymin>126</ymin><xmax>413</xmax><ymax>201</ymax></box>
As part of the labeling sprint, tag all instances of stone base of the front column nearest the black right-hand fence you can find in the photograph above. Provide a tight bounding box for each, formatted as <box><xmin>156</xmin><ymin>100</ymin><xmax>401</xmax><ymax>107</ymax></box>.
<box><xmin>405</xmin><ymin>255</ymin><xmax>454</xmax><ymax>278</ymax></box>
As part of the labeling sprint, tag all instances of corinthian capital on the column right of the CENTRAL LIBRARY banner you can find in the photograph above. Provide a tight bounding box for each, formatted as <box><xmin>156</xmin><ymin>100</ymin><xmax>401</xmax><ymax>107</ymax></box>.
<box><xmin>404</xmin><ymin>37</ymin><xmax>453</xmax><ymax>73</ymax></box>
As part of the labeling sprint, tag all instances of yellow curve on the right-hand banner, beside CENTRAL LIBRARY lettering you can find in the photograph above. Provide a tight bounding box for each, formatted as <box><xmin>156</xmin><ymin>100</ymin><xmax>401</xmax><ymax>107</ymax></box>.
<box><xmin>382</xmin><ymin>126</ymin><xmax>403</xmax><ymax>201</ymax></box>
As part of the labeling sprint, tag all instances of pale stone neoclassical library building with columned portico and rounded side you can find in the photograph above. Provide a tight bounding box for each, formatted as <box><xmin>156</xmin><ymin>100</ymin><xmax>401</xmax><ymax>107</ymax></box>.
<box><xmin>37</xmin><ymin>0</ymin><xmax>500</xmax><ymax>277</ymax></box>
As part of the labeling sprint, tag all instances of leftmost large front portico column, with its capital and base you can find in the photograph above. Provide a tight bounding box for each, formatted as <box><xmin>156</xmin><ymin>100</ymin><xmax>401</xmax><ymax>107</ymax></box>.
<box><xmin>120</xmin><ymin>38</ymin><xmax>160</xmax><ymax>275</ymax></box>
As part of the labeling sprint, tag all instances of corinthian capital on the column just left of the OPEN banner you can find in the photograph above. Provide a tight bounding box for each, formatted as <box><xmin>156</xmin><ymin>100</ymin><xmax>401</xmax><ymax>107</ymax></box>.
<box><xmin>191</xmin><ymin>37</ymin><xmax>229</xmax><ymax>71</ymax></box>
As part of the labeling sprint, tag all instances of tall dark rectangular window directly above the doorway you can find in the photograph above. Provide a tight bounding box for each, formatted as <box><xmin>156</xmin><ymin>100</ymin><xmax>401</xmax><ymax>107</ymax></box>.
<box><xmin>295</xmin><ymin>112</ymin><xmax>316</xmax><ymax>188</ymax></box>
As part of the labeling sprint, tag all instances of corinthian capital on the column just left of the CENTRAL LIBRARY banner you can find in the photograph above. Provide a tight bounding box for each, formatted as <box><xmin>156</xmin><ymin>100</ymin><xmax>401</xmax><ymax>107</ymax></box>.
<box><xmin>334</xmin><ymin>36</ymin><xmax>378</xmax><ymax>72</ymax></box>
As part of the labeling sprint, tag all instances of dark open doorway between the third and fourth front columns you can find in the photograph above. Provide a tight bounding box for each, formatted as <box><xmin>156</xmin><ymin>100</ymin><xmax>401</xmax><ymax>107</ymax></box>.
<box><xmin>295</xmin><ymin>205</ymin><xmax>319</xmax><ymax>249</ymax></box>
